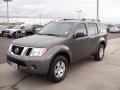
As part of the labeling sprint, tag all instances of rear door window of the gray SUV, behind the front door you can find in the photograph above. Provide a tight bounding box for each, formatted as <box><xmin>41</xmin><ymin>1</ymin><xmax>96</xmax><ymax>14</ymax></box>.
<box><xmin>88</xmin><ymin>23</ymin><xmax>98</xmax><ymax>35</ymax></box>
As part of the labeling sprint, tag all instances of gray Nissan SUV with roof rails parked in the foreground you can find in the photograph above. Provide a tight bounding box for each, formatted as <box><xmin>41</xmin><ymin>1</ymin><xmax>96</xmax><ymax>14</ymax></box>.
<box><xmin>7</xmin><ymin>20</ymin><xmax>107</xmax><ymax>82</ymax></box>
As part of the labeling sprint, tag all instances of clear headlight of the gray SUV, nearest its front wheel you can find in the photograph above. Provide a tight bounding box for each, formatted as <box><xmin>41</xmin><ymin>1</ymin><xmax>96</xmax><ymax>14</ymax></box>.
<box><xmin>30</xmin><ymin>48</ymin><xmax>47</xmax><ymax>56</ymax></box>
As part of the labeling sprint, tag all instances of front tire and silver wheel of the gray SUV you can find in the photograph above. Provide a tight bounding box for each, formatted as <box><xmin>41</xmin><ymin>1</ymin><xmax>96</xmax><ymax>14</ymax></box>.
<box><xmin>47</xmin><ymin>56</ymin><xmax>68</xmax><ymax>82</ymax></box>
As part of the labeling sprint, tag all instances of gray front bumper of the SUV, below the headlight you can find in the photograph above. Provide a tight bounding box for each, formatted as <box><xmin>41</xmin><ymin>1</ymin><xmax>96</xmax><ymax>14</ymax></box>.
<box><xmin>7</xmin><ymin>53</ymin><xmax>51</xmax><ymax>74</ymax></box>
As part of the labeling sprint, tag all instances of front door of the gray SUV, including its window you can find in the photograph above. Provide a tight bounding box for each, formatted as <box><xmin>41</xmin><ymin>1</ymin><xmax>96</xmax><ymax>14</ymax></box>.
<box><xmin>73</xmin><ymin>23</ymin><xmax>89</xmax><ymax>61</ymax></box>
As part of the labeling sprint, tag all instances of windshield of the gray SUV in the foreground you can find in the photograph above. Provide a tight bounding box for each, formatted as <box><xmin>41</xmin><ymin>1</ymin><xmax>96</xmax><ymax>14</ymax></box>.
<box><xmin>39</xmin><ymin>22</ymin><xmax>74</xmax><ymax>37</ymax></box>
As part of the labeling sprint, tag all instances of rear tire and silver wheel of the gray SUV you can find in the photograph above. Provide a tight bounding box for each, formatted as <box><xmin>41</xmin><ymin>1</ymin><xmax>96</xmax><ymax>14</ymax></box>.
<box><xmin>94</xmin><ymin>44</ymin><xmax>105</xmax><ymax>61</ymax></box>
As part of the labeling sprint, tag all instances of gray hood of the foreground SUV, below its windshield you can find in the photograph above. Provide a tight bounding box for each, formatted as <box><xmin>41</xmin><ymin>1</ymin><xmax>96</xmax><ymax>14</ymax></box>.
<box><xmin>12</xmin><ymin>35</ymin><xmax>65</xmax><ymax>48</ymax></box>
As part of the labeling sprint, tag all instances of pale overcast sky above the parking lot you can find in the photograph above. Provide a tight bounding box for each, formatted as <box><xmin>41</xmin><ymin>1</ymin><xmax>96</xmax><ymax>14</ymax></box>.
<box><xmin>0</xmin><ymin>0</ymin><xmax>120</xmax><ymax>23</ymax></box>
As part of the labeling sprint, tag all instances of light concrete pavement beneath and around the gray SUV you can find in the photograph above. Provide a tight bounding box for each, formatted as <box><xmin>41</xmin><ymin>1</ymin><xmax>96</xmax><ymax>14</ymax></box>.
<box><xmin>0</xmin><ymin>33</ymin><xmax>120</xmax><ymax>90</ymax></box>
